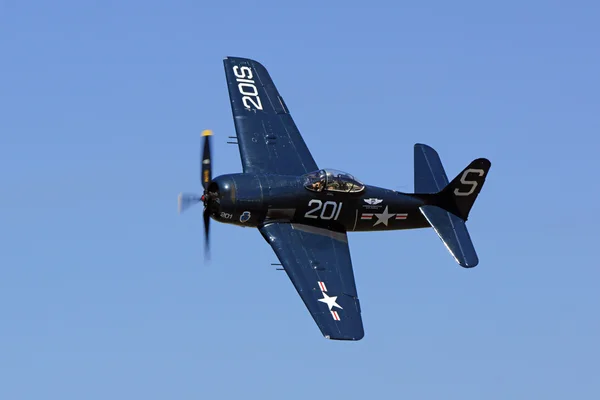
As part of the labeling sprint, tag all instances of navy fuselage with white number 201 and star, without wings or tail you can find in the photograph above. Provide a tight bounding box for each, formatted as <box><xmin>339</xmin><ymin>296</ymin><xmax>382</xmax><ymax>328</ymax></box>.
<box><xmin>209</xmin><ymin>173</ymin><xmax>430</xmax><ymax>232</ymax></box>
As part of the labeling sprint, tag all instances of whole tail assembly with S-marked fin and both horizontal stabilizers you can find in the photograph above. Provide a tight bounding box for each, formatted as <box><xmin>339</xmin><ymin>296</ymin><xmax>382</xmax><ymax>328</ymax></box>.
<box><xmin>415</xmin><ymin>144</ymin><xmax>491</xmax><ymax>268</ymax></box>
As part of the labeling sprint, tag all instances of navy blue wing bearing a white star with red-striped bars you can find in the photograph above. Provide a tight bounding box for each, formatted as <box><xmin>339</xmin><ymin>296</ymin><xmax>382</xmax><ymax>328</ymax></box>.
<box><xmin>260</xmin><ymin>222</ymin><xmax>364</xmax><ymax>340</ymax></box>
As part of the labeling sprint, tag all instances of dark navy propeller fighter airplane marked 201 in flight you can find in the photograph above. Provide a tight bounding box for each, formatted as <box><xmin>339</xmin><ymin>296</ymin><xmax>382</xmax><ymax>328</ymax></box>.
<box><xmin>178</xmin><ymin>57</ymin><xmax>491</xmax><ymax>341</ymax></box>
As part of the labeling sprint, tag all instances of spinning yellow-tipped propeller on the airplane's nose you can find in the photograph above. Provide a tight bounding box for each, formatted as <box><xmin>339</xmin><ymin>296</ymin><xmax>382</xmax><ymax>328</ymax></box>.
<box><xmin>178</xmin><ymin>129</ymin><xmax>212</xmax><ymax>258</ymax></box>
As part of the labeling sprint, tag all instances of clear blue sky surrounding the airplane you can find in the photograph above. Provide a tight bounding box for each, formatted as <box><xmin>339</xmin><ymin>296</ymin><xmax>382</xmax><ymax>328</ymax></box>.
<box><xmin>0</xmin><ymin>0</ymin><xmax>600</xmax><ymax>400</ymax></box>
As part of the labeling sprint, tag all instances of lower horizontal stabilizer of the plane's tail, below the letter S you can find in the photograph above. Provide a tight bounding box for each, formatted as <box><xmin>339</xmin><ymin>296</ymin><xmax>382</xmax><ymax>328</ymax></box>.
<box><xmin>419</xmin><ymin>205</ymin><xmax>479</xmax><ymax>268</ymax></box>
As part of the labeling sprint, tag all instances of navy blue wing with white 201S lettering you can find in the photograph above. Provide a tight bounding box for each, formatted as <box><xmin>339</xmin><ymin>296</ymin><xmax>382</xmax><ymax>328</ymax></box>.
<box><xmin>223</xmin><ymin>57</ymin><xmax>318</xmax><ymax>175</ymax></box>
